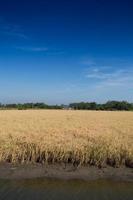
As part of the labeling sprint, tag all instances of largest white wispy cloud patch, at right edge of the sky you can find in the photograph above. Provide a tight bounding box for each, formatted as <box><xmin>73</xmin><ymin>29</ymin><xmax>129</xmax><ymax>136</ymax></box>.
<box><xmin>82</xmin><ymin>58</ymin><xmax>133</xmax><ymax>88</ymax></box>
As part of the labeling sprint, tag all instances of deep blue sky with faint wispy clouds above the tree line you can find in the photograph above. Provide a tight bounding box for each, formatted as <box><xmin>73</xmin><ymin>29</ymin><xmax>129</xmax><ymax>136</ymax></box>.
<box><xmin>0</xmin><ymin>0</ymin><xmax>133</xmax><ymax>104</ymax></box>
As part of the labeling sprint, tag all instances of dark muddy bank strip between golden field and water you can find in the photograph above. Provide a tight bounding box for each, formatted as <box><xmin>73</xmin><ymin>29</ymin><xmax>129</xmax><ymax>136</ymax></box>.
<box><xmin>0</xmin><ymin>163</ymin><xmax>133</xmax><ymax>182</ymax></box>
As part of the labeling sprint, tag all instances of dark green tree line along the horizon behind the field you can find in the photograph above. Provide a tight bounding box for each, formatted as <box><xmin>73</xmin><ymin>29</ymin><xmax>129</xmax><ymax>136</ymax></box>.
<box><xmin>0</xmin><ymin>101</ymin><xmax>133</xmax><ymax>111</ymax></box>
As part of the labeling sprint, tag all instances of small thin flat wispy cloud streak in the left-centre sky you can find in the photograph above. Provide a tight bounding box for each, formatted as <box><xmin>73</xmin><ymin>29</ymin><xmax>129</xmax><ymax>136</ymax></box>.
<box><xmin>16</xmin><ymin>47</ymin><xmax>48</xmax><ymax>52</ymax></box>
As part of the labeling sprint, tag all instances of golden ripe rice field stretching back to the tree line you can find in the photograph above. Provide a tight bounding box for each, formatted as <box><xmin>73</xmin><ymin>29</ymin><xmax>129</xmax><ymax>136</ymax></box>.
<box><xmin>0</xmin><ymin>110</ymin><xmax>133</xmax><ymax>167</ymax></box>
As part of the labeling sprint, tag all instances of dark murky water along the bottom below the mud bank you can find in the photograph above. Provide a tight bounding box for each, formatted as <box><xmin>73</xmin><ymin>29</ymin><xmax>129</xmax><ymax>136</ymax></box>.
<box><xmin>0</xmin><ymin>179</ymin><xmax>133</xmax><ymax>200</ymax></box>
